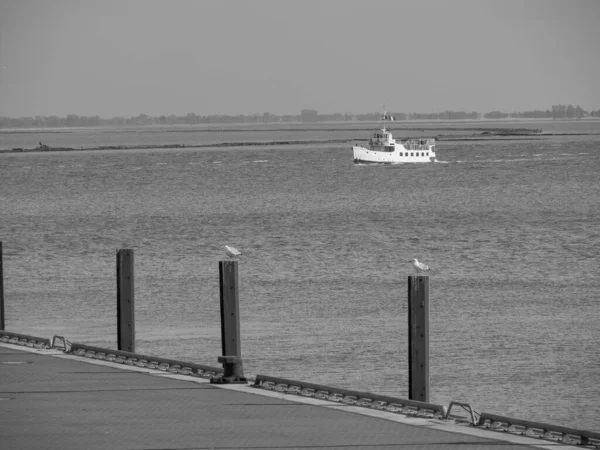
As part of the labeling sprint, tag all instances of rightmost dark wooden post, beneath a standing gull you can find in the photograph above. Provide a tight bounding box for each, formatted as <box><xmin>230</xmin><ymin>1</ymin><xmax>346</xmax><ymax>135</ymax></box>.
<box><xmin>408</xmin><ymin>275</ymin><xmax>429</xmax><ymax>403</ymax></box>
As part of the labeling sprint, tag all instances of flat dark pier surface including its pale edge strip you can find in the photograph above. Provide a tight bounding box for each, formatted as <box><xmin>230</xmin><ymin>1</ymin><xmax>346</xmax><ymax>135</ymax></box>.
<box><xmin>0</xmin><ymin>344</ymin><xmax>576</xmax><ymax>450</ymax></box>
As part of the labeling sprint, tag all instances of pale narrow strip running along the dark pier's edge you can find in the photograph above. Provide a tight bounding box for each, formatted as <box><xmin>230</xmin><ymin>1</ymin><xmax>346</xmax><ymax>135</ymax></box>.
<box><xmin>0</xmin><ymin>343</ymin><xmax>582</xmax><ymax>450</ymax></box>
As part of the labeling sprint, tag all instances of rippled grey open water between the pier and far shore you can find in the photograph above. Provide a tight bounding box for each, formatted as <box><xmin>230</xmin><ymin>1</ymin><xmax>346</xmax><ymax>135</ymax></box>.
<box><xmin>0</xmin><ymin>120</ymin><xmax>600</xmax><ymax>431</ymax></box>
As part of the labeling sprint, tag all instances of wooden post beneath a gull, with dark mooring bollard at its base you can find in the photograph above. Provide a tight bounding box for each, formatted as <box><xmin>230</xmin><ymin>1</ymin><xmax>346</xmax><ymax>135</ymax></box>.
<box><xmin>210</xmin><ymin>261</ymin><xmax>246</xmax><ymax>384</ymax></box>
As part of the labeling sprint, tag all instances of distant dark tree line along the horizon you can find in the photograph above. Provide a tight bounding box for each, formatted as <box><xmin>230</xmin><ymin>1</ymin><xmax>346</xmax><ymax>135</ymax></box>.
<box><xmin>0</xmin><ymin>105</ymin><xmax>600</xmax><ymax>128</ymax></box>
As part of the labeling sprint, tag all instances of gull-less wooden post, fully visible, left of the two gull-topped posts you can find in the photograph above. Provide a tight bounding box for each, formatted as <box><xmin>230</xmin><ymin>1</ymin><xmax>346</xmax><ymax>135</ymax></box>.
<box><xmin>117</xmin><ymin>249</ymin><xmax>135</xmax><ymax>353</ymax></box>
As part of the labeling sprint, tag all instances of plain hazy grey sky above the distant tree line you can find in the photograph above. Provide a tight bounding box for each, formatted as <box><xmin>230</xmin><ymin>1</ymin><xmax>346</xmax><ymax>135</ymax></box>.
<box><xmin>0</xmin><ymin>0</ymin><xmax>600</xmax><ymax>118</ymax></box>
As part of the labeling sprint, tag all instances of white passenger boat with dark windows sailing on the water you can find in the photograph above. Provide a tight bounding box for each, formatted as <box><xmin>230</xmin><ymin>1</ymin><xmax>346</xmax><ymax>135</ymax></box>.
<box><xmin>352</xmin><ymin>128</ymin><xmax>437</xmax><ymax>164</ymax></box>
